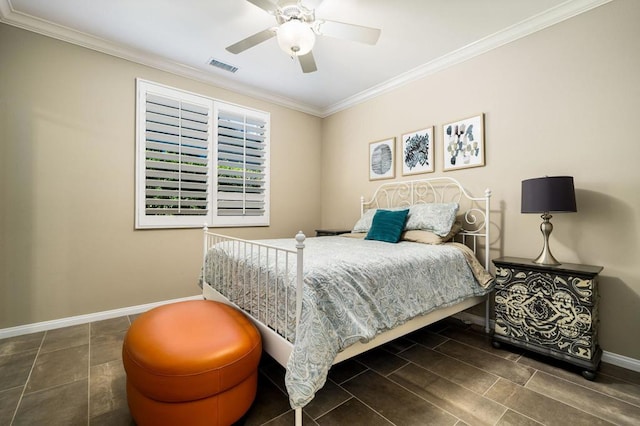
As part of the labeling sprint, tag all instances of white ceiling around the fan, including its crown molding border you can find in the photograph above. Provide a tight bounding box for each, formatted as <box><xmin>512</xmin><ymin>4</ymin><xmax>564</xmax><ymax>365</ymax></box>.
<box><xmin>0</xmin><ymin>0</ymin><xmax>609</xmax><ymax>117</ymax></box>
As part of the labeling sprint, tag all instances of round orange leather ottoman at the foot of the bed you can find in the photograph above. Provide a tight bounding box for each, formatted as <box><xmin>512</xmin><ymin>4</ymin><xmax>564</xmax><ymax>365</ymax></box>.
<box><xmin>122</xmin><ymin>300</ymin><xmax>262</xmax><ymax>426</ymax></box>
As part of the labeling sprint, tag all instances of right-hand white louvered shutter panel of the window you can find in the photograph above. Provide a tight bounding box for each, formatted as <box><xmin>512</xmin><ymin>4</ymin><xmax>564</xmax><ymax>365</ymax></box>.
<box><xmin>215</xmin><ymin>103</ymin><xmax>269</xmax><ymax>226</ymax></box>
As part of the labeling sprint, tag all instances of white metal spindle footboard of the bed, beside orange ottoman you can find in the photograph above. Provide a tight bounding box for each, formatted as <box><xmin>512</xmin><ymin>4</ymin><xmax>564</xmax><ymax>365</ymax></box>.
<box><xmin>202</xmin><ymin>225</ymin><xmax>306</xmax><ymax>365</ymax></box>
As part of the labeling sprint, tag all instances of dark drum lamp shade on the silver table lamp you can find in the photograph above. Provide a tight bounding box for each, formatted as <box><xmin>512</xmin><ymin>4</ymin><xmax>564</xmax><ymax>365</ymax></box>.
<box><xmin>521</xmin><ymin>176</ymin><xmax>578</xmax><ymax>213</ymax></box>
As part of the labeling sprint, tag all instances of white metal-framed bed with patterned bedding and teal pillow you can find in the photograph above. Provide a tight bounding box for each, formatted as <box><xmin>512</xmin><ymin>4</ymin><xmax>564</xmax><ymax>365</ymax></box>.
<box><xmin>200</xmin><ymin>177</ymin><xmax>493</xmax><ymax>425</ymax></box>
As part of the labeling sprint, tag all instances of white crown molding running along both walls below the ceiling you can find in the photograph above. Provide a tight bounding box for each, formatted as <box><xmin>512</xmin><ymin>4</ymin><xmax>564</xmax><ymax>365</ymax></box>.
<box><xmin>0</xmin><ymin>0</ymin><xmax>612</xmax><ymax>118</ymax></box>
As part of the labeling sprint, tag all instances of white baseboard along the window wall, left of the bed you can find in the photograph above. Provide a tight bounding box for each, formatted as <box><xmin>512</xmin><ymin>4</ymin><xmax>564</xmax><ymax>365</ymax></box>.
<box><xmin>0</xmin><ymin>295</ymin><xmax>202</xmax><ymax>339</ymax></box>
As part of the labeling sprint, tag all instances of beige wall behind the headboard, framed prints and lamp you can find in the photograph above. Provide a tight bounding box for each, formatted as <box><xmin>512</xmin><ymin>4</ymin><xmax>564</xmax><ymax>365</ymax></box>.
<box><xmin>322</xmin><ymin>0</ymin><xmax>640</xmax><ymax>359</ymax></box>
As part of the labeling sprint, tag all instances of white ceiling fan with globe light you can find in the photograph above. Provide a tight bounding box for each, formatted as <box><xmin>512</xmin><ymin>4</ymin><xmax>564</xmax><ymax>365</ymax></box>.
<box><xmin>227</xmin><ymin>0</ymin><xmax>380</xmax><ymax>73</ymax></box>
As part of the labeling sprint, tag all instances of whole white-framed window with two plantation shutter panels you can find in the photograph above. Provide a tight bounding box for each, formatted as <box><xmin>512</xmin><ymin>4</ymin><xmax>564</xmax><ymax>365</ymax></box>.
<box><xmin>136</xmin><ymin>80</ymin><xmax>270</xmax><ymax>229</ymax></box>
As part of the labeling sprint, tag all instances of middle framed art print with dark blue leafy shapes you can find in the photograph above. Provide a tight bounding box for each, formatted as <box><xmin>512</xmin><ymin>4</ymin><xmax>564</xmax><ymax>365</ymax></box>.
<box><xmin>400</xmin><ymin>127</ymin><xmax>435</xmax><ymax>176</ymax></box>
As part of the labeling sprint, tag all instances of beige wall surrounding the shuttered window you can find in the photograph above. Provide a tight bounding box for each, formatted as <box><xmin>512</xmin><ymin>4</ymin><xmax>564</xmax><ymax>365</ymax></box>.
<box><xmin>0</xmin><ymin>24</ymin><xmax>321</xmax><ymax>328</ymax></box>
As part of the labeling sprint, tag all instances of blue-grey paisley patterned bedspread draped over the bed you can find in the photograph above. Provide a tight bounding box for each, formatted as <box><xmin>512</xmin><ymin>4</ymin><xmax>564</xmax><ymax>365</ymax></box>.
<box><xmin>206</xmin><ymin>236</ymin><xmax>487</xmax><ymax>408</ymax></box>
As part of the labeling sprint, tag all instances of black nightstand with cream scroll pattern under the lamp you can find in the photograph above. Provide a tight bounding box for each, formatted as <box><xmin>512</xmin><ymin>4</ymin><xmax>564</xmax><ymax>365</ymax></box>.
<box><xmin>493</xmin><ymin>257</ymin><xmax>603</xmax><ymax>380</ymax></box>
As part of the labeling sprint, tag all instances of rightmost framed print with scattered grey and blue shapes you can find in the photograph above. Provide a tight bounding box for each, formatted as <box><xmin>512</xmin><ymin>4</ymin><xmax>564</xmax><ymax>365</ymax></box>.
<box><xmin>442</xmin><ymin>114</ymin><xmax>484</xmax><ymax>171</ymax></box>
